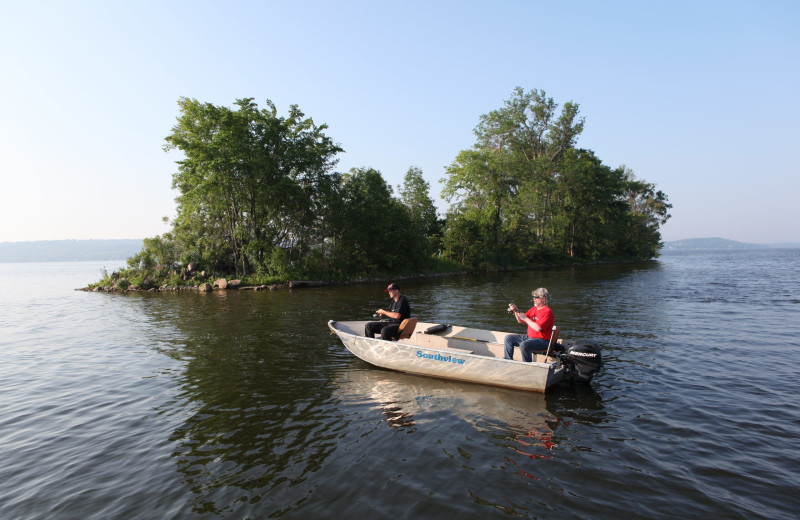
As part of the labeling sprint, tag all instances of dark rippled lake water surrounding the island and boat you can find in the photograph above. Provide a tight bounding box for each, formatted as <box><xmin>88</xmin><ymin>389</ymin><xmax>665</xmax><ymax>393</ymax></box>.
<box><xmin>0</xmin><ymin>249</ymin><xmax>800</xmax><ymax>520</ymax></box>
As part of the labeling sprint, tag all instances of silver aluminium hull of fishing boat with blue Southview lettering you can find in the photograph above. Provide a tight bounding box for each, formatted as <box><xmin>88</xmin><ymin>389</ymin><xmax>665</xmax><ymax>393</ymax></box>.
<box><xmin>328</xmin><ymin>320</ymin><xmax>564</xmax><ymax>392</ymax></box>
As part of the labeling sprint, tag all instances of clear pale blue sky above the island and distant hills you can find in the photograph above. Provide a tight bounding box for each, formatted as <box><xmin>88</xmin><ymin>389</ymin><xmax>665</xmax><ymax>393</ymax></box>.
<box><xmin>0</xmin><ymin>0</ymin><xmax>800</xmax><ymax>243</ymax></box>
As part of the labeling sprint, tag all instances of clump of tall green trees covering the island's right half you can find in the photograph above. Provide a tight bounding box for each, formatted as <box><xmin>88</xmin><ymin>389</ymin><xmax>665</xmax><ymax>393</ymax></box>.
<box><xmin>442</xmin><ymin>88</ymin><xmax>671</xmax><ymax>267</ymax></box>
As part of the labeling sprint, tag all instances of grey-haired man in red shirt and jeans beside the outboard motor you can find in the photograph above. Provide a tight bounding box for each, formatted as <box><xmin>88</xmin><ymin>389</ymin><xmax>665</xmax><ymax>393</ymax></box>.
<box><xmin>504</xmin><ymin>287</ymin><xmax>555</xmax><ymax>363</ymax></box>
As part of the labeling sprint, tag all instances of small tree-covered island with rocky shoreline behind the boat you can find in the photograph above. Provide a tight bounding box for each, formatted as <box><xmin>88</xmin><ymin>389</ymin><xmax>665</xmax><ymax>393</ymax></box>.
<box><xmin>90</xmin><ymin>88</ymin><xmax>672</xmax><ymax>290</ymax></box>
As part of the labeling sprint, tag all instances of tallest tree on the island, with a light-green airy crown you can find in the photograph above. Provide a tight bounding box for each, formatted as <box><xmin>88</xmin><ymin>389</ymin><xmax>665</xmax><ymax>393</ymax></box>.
<box><xmin>442</xmin><ymin>87</ymin><xmax>584</xmax><ymax>263</ymax></box>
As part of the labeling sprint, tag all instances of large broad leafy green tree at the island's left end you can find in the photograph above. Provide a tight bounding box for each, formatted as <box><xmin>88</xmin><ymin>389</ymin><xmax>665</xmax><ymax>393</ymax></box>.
<box><xmin>165</xmin><ymin>98</ymin><xmax>342</xmax><ymax>275</ymax></box>
